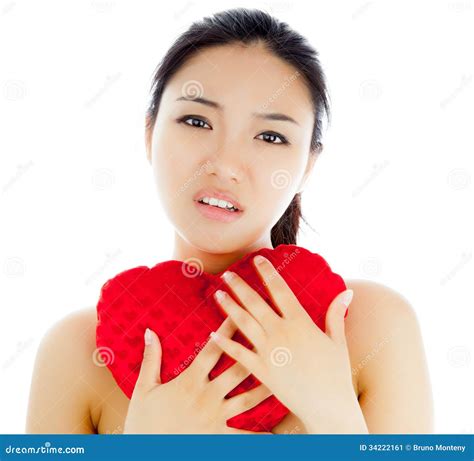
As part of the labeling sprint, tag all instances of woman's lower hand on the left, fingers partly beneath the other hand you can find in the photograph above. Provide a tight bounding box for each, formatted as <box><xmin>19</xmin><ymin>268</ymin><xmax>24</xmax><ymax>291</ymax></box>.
<box><xmin>123</xmin><ymin>318</ymin><xmax>271</xmax><ymax>434</ymax></box>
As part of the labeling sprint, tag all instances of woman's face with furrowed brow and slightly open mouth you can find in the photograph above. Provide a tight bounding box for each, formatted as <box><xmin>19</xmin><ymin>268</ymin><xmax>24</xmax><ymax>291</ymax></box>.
<box><xmin>147</xmin><ymin>44</ymin><xmax>316</xmax><ymax>253</ymax></box>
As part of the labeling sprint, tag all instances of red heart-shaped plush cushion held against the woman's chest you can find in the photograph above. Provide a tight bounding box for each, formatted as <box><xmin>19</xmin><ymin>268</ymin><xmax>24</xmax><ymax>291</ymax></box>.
<box><xmin>96</xmin><ymin>244</ymin><xmax>347</xmax><ymax>432</ymax></box>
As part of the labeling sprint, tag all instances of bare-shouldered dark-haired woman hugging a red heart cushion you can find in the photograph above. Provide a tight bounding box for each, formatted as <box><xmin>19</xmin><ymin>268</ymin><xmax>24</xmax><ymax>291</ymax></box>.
<box><xmin>27</xmin><ymin>9</ymin><xmax>433</xmax><ymax>433</ymax></box>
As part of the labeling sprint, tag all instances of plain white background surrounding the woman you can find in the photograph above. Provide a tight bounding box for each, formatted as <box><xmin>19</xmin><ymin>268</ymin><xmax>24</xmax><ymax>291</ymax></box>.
<box><xmin>0</xmin><ymin>0</ymin><xmax>474</xmax><ymax>433</ymax></box>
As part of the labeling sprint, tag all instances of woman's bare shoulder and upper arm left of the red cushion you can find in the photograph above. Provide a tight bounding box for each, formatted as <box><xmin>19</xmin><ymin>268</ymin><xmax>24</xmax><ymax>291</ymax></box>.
<box><xmin>26</xmin><ymin>308</ymin><xmax>109</xmax><ymax>434</ymax></box>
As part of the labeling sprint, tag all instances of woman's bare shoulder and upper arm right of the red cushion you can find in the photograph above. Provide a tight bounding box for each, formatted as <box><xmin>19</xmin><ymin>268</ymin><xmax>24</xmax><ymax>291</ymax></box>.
<box><xmin>345</xmin><ymin>279</ymin><xmax>433</xmax><ymax>433</ymax></box>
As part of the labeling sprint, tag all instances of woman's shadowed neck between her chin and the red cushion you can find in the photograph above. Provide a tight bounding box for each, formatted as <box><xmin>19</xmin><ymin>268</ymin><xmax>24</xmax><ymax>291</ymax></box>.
<box><xmin>172</xmin><ymin>232</ymin><xmax>273</xmax><ymax>274</ymax></box>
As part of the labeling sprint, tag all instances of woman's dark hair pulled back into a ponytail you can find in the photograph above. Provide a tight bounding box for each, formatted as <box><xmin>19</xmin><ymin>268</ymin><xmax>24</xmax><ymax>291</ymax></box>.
<box><xmin>146</xmin><ymin>8</ymin><xmax>331</xmax><ymax>248</ymax></box>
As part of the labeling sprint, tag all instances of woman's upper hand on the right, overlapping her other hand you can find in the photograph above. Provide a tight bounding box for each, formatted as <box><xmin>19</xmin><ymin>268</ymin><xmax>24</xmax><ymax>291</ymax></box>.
<box><xmin>211</xmin><ymin>253</ymin><xmax>367</xmax><ymax>433</ymax></box>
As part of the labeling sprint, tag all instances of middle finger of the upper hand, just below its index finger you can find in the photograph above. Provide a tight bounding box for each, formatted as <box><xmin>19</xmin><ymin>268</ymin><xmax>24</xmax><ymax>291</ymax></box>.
<box><xmin>222</xmin><ymin>271</ymin><xmax>280</xmax><ymax>331</ymax></box>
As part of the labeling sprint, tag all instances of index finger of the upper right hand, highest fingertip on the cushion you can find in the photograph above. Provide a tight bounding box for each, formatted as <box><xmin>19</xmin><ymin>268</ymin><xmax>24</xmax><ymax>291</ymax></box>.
<box><xmin>253</xmin><ymin>255</ymin><xmax>302</xmax><ymax>318</ymax></box>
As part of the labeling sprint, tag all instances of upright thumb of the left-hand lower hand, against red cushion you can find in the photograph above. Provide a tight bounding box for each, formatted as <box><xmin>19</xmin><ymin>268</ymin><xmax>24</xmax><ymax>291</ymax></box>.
<box><xmin>135</xmin><ymin>328</ymin><xmax>162</xmax><ymax>392</ymax></box>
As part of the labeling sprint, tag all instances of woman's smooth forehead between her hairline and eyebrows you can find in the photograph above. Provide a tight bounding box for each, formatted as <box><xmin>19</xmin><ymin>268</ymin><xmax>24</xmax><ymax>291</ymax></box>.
<box><xmin>163</xmin><ymin>44</ymin><xmax>313</xmax><ymax>120</ymax></box>
